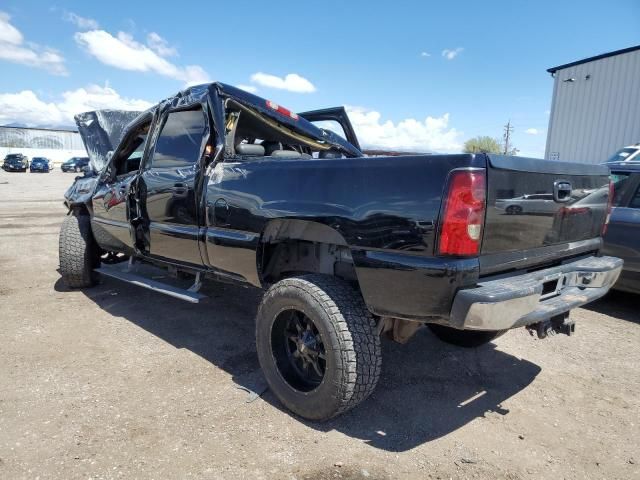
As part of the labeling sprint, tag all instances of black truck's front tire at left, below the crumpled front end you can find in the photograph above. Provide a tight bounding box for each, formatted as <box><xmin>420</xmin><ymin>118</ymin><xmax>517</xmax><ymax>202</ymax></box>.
<box><xmin>58</xmin><ymin>213</ymin><xmax>100</xmax><ymax>288</ymax></box>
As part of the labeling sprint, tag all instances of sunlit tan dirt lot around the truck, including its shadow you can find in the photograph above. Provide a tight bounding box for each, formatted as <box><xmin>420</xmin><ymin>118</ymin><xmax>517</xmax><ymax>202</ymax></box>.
<box><xmin>0</xmin><ymin>171</ymin><xmax>640</xmax><ymax>479</ymax></box>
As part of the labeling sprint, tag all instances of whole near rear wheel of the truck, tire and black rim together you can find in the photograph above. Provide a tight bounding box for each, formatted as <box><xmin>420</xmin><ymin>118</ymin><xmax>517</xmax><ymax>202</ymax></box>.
<box><xmin>256</xmin><ymin>274</ymin><xmax>382</xmax><ymax>420</ymax></box>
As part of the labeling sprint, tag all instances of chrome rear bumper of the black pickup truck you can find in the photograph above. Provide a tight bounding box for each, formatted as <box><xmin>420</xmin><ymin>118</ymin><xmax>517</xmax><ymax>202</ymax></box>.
<box><xmin>449</xmin><ymin>257</ymin><xmax>623</xmax><ymax>330</ymax></box>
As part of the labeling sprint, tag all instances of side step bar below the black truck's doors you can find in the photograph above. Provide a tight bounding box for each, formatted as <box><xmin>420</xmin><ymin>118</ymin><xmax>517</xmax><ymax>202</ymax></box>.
<box><xmin>95</xmin><ymin>263</ymin><xmax>207</xmax><ymax>303</ymax></box>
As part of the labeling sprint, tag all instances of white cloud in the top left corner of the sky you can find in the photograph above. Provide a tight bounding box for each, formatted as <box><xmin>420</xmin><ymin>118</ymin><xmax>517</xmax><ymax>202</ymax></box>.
<box><xmin>0</xmin><ymin>11</ymin><xmax>67</xmax><ymax>75</ymax></box>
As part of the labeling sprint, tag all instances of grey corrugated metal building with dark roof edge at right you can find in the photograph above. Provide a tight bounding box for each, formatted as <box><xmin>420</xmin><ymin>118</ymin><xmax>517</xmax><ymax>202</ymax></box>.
<box><xmin>545</xmin><ymin>45</ymin><xmax>640</xmax><ymax>163</ymax></box>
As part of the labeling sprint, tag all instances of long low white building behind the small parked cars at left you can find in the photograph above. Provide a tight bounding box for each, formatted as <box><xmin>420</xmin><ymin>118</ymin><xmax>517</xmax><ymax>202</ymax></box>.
<box><xmin>0</xmin><ymin>126</ymin><xmax>87</xmax><ymax>165</ymax></box>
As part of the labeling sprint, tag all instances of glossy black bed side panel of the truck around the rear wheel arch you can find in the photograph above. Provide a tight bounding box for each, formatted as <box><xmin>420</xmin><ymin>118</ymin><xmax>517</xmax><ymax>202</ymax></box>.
<box><xmin>206</xmin><ymin>155</ymin><xmax>486</xmax><ymax>318</ymax></box>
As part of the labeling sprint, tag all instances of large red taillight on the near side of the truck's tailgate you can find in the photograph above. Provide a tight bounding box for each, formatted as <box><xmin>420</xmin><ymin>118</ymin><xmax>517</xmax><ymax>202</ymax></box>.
<box><xmin>438</xmin><ymin>170</ymin><xmax>487</xmax><ymax>256</ymax></box>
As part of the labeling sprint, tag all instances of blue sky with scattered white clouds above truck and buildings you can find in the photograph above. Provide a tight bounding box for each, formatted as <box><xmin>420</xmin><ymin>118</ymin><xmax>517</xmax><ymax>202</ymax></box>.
<box><xmin>0</xmin><ymin>0</ymin><xmax>640</xmax><ymax>156</ymax></box>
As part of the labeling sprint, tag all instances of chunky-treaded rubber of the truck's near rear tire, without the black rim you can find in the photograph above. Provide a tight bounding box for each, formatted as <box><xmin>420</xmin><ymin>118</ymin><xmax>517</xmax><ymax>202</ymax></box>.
<box><xmin>256</xmin><ymin>274</ymin><xmax>382</xmax><ymax>421</ymax></box>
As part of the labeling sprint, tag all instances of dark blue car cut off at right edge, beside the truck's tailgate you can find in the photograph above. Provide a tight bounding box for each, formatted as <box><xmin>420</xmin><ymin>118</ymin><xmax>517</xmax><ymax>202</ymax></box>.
<box><xmin>603</xmin><ymin>162</ymin><xmax>640</xmax><ymax>293</ymax></box>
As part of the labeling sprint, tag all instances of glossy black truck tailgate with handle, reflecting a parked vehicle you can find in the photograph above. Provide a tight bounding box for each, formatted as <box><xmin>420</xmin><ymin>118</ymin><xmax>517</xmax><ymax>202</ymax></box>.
<box><xmin>481</xmin><ymin>155</ymin><xmax>609</xmax><ymax>273</ymax></box>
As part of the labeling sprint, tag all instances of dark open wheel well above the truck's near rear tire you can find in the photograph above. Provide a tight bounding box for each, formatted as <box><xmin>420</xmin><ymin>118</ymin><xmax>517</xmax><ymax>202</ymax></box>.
<box><xmin>259</xmin><ymin>220</ymin><xmax>357</xmax><ymax>285</ymax></box>
